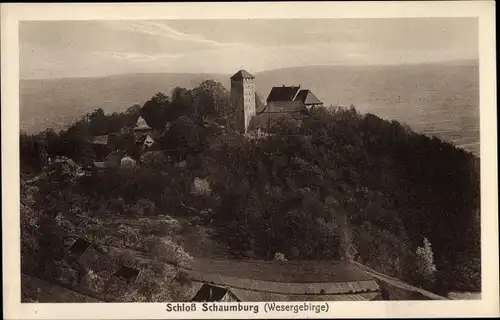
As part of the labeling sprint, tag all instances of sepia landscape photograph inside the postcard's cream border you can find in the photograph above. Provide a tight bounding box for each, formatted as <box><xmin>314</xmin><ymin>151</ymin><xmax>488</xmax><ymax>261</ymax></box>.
<box><xmin>2</xmin><ymin>1</ymin><xmax>498</xmax><ymax>316</ymax></box>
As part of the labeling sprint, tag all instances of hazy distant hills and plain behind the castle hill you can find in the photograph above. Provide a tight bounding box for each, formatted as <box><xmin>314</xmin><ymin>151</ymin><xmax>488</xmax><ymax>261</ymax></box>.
<box><xmin>20</xmin><ymin>61</ymin><xmax>479</xmax><ymax>155</ymax></box>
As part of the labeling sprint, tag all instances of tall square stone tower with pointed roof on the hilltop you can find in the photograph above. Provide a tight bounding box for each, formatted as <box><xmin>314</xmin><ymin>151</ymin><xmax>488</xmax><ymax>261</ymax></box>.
<box><xmin>231</xmin><ymin>70</ymin><xmax>255</xmax><ymax>133</ymax></box>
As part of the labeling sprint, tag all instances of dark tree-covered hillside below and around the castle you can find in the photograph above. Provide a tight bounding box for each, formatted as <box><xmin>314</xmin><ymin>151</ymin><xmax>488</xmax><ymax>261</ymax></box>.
<box><xmin>20</xmin><ymin>80</ymin><xmax>481</xmax><ymax>300</ymax></box>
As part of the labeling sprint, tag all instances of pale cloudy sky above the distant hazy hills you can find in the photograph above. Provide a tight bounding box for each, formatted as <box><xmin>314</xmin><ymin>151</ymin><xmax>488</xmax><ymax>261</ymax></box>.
<box><xmin>19</xmin><ymin>18</ymin><xmax>479</xmax><ymax>79</ymax></box>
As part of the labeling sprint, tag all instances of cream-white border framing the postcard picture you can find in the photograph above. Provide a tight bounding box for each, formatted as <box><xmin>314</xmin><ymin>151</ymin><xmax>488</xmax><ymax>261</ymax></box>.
<box><xmin>1</xmin><ymin>1</ymin><xmax>499</xmax><ymax>319</ymax></box>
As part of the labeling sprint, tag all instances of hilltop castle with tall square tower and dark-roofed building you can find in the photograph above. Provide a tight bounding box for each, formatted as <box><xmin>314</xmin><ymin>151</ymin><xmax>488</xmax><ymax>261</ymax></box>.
<box><xmin>230</xmin><ymin>70</ymin><xmax>323</xmax><ymax>133</ymax></box>
